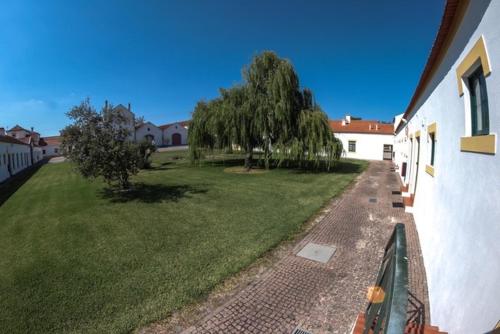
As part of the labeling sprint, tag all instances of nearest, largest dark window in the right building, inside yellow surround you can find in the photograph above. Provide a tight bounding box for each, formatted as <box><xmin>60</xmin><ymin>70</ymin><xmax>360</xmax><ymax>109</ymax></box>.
<box><xmin>468</xmin><ymin>66</ymin><xmax>490</xmax><ymax>136</ymax></box>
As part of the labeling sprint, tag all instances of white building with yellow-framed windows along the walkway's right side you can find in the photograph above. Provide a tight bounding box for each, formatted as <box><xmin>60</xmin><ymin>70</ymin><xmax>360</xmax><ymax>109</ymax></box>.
<box><xmin>395</xmin><ymin>0</ymin><xmax>500</xmax><ymax>333</ymax></box>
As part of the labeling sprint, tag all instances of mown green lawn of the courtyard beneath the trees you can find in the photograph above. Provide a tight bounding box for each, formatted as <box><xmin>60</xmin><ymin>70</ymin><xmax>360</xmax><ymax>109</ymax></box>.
<box><xmin>0</xmin><ymin>152</ymin><xmax>366</xmax><ymax>333</ymax></box>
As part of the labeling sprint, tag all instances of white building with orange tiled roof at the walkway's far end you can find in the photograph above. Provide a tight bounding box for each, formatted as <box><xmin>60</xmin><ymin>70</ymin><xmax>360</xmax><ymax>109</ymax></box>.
<box><xmin>330</xmin><ymin>116</ymin><xmax>394</xmax><ymax>160</ymax></box>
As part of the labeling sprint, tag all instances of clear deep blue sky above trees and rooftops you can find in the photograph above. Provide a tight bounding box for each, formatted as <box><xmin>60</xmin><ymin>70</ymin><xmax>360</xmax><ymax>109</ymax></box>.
<box><xmin>0</xmin><ymin>0</ymin><xmax>444</xmax><ymax>136</ymax></box>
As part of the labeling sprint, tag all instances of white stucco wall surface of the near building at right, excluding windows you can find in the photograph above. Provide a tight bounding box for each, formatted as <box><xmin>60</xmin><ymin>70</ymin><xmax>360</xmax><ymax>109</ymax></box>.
<box><xmin>395</xmin><ymin>1</ymin><xmax>500</xmax><ymax>333</ymax></box>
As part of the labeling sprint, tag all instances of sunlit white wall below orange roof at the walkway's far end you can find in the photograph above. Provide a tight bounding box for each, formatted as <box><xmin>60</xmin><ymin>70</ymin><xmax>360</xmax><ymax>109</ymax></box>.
<box><xmin>335</xmin><ymin>133</ymin><xmax>394</xmax><ymax>160</ymax></box>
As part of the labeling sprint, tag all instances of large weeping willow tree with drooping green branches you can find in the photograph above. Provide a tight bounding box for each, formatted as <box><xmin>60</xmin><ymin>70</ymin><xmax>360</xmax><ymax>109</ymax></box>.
<box><xmin>188</xmin><ymin>52</ymin><xmax>342</xmax><ymax>169</ymax></box>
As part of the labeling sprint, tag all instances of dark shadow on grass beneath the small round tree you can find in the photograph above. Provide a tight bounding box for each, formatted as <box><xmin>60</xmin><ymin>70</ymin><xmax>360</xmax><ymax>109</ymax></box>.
<box><xmin>100</xmin><ymin>183</ymin><xmax>208</xmax><ymax>203</ymax></box>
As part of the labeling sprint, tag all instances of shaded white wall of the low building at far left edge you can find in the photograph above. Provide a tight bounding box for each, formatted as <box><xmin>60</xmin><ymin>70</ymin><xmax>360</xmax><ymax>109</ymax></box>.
<box><xmin>0</xmin><ymin>142</ymin><xmax>31</xmax><ymax>182</ymax></box>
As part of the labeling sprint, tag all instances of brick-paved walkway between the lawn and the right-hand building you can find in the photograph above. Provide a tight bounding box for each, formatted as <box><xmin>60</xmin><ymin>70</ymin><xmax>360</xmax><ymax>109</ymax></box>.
<box><xmin>185</xmin><ymin>162</ymin><xmax>428</xmax><ymax>334</ymax></box>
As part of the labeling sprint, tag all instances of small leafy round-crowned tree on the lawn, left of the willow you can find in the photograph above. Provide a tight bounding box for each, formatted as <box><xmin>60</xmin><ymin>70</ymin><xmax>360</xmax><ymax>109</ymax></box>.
<box><xmin>62</xmin><ymin>99</ymin><xmax>143</xmax><ymax>189</ymax></box>
